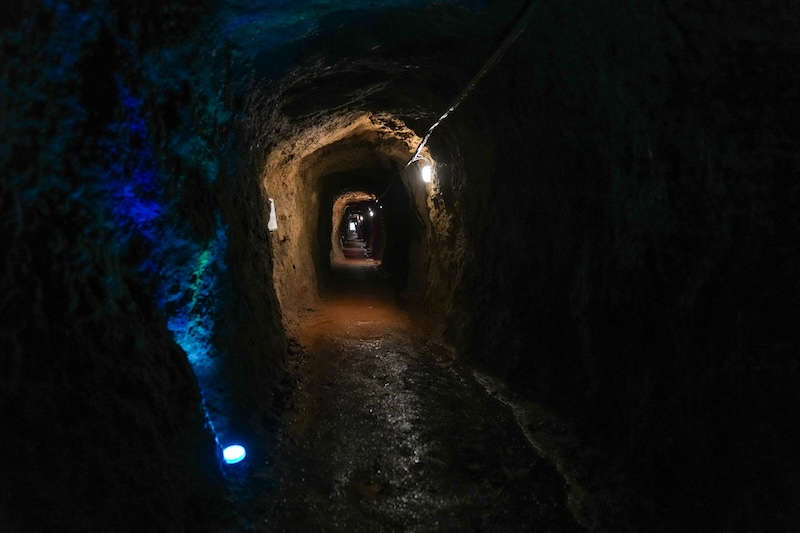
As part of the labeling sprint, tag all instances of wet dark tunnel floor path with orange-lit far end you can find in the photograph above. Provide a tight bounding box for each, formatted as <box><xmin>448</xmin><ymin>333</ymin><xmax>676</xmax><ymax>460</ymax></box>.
<box><xmin>264</xmin><ymin>268</ymin><xmax>579</xmax><ymax>532</ymax></box>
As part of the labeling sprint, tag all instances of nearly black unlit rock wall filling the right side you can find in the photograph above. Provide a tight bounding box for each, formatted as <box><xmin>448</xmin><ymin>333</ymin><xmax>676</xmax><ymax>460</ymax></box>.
<box><xmin>450</xmin><ymin>1</ymin><xmax>800</xmax><ymax>531</ymax></box>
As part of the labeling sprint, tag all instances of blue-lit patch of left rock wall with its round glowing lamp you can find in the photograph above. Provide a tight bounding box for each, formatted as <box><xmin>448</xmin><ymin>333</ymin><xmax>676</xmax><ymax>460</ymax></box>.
<box><xmin>100</xmin><ymin>80</ymin><xmax>234</xmax><ymax>464</ymax></box>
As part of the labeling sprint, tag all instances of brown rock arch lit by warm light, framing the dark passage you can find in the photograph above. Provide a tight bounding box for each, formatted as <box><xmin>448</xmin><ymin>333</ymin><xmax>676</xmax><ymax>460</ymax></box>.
<box><xmin>261</xmin><ymin>112</ymin><xmax>442</xmax><ymax>322</ymax></box>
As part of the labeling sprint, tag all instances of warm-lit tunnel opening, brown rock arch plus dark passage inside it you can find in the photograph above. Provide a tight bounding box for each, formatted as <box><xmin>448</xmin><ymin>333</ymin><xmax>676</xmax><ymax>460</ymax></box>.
<box><xmin>263</xmin><ymin>114</ymin><xmax>450</xmax><ymax>324</ymax></box>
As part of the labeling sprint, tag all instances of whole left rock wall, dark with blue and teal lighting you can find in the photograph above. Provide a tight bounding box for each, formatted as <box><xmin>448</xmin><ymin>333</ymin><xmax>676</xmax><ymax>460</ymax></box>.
<box><xmin>0</xmin><ymin>2</ymin><xmax>230</xmax><ymax>531</ymax></box>
